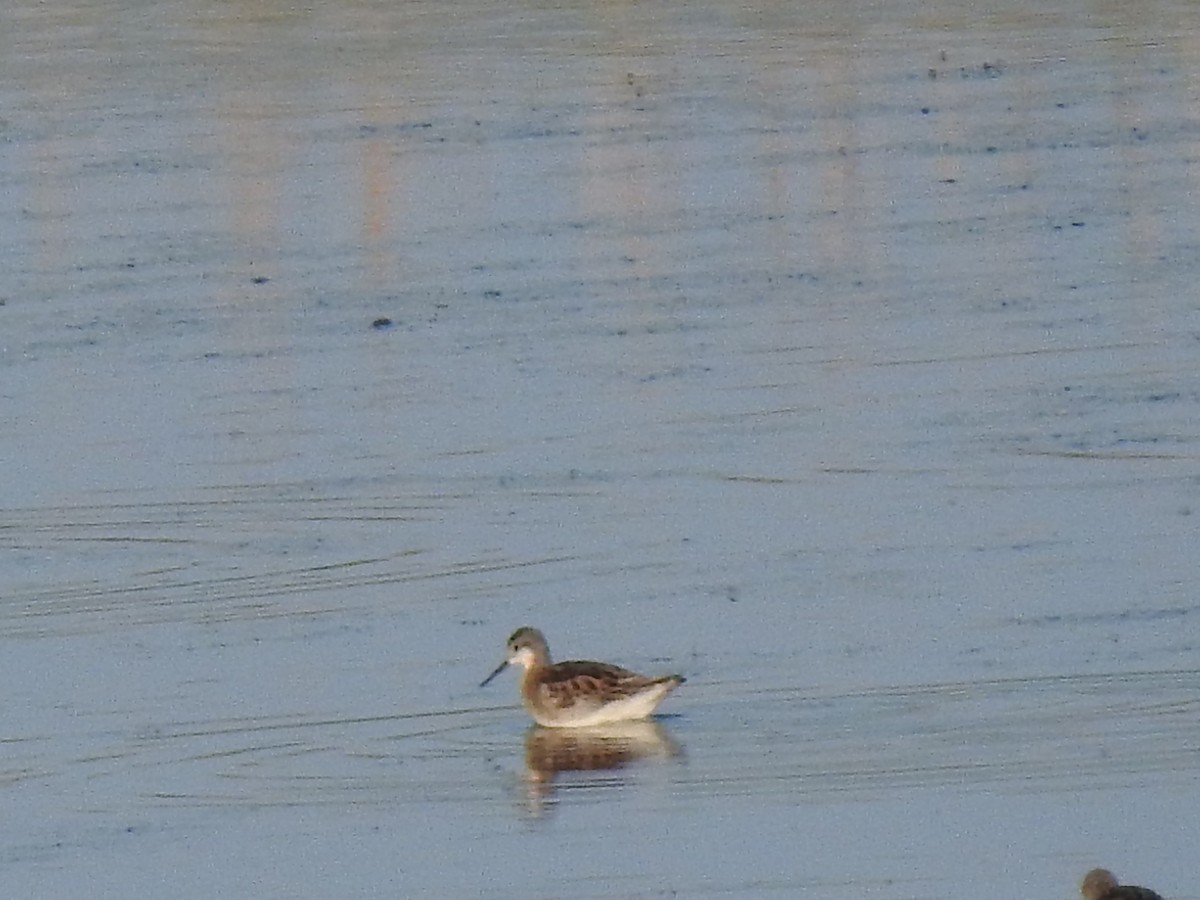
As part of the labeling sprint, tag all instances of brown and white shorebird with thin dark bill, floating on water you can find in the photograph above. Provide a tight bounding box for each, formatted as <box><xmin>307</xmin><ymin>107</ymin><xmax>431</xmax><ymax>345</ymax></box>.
<box><xmin>480</xmin><ymin>628</ymin><xmax>684</xmax><ymax>728</ymax></box>
